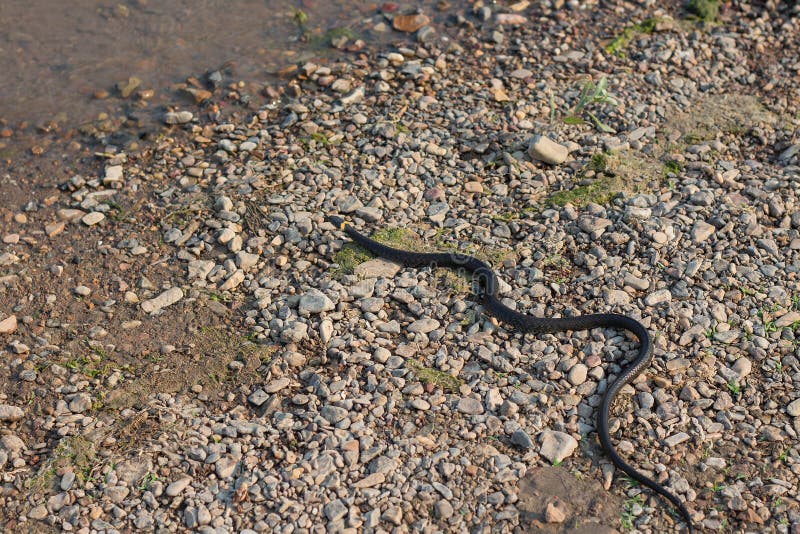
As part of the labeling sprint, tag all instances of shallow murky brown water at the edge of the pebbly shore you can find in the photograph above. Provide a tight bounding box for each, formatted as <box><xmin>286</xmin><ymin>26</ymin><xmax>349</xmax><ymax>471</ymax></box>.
<box><xmin>0</xmin><ymin>0</ymin><xmax>450</xmax><ymax>129</ymax></box>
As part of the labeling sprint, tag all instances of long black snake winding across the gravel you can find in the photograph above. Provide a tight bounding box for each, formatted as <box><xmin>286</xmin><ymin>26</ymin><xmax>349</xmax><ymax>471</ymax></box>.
<box><xmin>327</xmin><ymin>216</ymin><xmax>692</xmax><ymax>533</ymax></box>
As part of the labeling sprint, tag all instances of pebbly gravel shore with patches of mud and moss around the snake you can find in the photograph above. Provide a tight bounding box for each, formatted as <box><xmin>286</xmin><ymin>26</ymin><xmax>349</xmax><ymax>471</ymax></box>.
<box><xmin>0</xmin><ymin>1</ymin><xmax>800</xmax><ymax>533</ymax></box>
